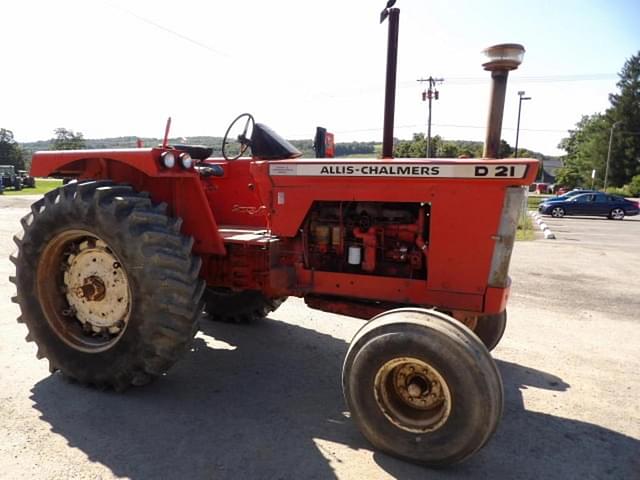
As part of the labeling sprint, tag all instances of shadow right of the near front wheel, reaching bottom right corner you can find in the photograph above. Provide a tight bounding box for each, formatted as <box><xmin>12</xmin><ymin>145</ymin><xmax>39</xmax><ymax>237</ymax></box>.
<box><xmin>374</xmin><ymin>360</ymin><xmax>640</xmax><ymax>480</ymax></box>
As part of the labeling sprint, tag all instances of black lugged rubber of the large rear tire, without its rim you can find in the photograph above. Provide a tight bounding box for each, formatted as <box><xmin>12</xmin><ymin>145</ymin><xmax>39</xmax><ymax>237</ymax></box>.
<box><xmin>10</xmin><ymin>180</ymin><xmax>205</xmax><ymax>391</ymax></box>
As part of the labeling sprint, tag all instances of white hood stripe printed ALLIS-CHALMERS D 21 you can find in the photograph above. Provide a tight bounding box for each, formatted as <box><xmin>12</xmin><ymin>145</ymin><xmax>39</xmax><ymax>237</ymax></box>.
<box><xmin>269</xmin><ymin>163</ymin><xmax>527</xmax><ymax>178</ymax></box>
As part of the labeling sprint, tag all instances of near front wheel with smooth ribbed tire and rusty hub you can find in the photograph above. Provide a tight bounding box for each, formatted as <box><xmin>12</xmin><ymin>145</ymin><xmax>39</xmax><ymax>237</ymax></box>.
<box><xmin>342</xmin><ymin>308</ymin><xmax>503</xmax><ymax>467</ymax></box>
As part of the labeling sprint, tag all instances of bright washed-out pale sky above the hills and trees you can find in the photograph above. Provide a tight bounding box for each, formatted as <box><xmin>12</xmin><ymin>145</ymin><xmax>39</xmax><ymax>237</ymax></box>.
<box><xmin>0</xmin><ymin>0</ymin><xmax>640</xmax><ymax>155</ymax></box>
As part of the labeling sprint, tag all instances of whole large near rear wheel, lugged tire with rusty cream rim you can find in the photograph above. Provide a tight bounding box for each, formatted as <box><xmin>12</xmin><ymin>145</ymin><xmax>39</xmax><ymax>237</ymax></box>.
<box><xmin>11</xmin><ymin>181</ymin><xmax>204</xmax><ymax>390</ymax></box>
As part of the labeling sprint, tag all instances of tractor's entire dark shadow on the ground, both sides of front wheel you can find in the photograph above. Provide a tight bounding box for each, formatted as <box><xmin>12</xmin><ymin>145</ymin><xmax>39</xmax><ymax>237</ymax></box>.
<box><xmin>31</xmin><ymin>315</ymin><xmax>640</xmax><ymax>479</ymax></box>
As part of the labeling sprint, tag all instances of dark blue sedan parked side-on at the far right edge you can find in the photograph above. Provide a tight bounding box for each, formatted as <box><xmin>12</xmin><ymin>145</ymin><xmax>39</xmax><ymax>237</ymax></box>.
<box><xmin>538</xmin><ymin>192</ymin><xmax>640</xmax><ymax>220</ymax></box>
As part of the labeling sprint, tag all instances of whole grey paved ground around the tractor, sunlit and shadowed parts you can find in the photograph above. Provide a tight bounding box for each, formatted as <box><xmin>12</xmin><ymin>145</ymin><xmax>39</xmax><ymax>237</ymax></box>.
<box><xmin>0</xmin><ymin>197</ymin><xmax>640</xmax><ymax>480</ymax></box>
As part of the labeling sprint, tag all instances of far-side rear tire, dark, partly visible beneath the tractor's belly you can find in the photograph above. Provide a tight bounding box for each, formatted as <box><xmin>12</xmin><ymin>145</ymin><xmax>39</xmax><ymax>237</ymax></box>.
<box><xmin>204</xmin><ymin>287</ymin><xmax>287</xmax><ymax>323</ymax></box>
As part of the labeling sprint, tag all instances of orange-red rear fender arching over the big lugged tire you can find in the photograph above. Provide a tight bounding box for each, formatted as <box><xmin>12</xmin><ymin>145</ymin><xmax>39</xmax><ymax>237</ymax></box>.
<box><xmin>31</xmin><ymin>148</ymin><xmax>226</xmax><ymax>255</ymax></box>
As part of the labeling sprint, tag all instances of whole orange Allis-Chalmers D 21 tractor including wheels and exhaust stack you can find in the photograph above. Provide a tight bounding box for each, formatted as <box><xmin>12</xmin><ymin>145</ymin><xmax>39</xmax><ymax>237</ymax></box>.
<box><xmin>11</xmin><ymin>5</ymin><xmax>538</xmax><ymax>466</ymax></box>
